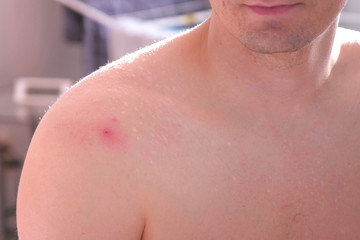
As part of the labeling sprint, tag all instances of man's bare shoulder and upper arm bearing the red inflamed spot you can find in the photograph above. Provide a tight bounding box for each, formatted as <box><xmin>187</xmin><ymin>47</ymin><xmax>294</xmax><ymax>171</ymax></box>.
<box><xmin>18</xmin><ymin>34</ymin><xmax>200</xmax><ymax>240</ymax></box>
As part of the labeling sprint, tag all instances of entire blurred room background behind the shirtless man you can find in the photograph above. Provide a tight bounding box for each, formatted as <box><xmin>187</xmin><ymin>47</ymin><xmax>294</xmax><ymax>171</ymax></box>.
<box><xmin>0</xmin><ymin>0</ymin><xmax>360</xmax><ymax>240</ymax></box>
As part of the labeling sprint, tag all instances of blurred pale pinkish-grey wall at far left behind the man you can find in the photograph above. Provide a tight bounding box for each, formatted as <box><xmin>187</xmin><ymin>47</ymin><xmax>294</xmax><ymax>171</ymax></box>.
<box><xmin>0</xmin><ymin>0</ymin><xmax>82</xmax><ymax>158</ymax></box>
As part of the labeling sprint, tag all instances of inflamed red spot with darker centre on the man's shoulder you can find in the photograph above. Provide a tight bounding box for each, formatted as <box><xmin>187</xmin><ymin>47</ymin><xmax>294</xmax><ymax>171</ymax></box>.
<box><xmin>96</xmin><ymin>117</ymin><xmax>128</xmax><ymax>152</ymax></box>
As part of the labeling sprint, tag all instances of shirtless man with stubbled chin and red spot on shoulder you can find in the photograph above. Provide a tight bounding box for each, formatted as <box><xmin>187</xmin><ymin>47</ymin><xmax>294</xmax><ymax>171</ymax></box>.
<box><xmin>18</xmin><ymin>0</ymin><xmax>360</xmax><ymax>240</ymax></box>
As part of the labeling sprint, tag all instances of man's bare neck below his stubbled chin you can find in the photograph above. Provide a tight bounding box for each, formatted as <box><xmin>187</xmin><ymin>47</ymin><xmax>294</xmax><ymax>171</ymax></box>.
<box><xmin>204</xmin><ymin>16</ymin><xmax>338</xmax><ymax>115</ymax></box>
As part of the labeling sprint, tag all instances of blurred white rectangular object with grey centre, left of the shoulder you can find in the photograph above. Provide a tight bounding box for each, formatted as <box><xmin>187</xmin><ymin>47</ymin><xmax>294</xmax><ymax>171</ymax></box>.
<box><xmin>13</xmin><ymin>78</ymin><xmax>72</xmax><ymax>120</ymax></box>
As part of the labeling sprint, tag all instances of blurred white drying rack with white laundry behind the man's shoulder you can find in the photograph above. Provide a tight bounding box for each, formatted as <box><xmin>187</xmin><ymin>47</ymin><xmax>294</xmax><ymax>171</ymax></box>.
<box><xmin>56</xmin><ymin>0</ymin><xmax>211</xmax><ymax>61</ymax></box>
